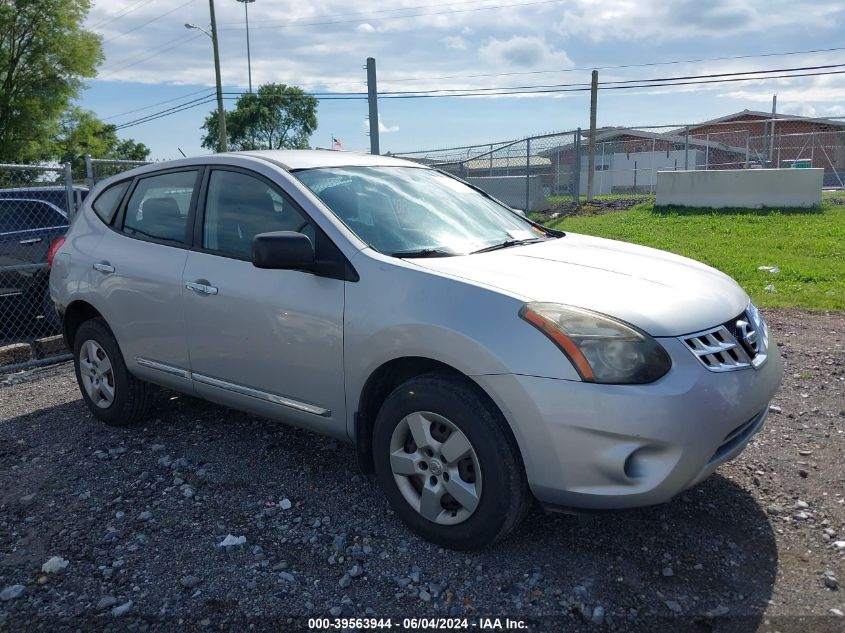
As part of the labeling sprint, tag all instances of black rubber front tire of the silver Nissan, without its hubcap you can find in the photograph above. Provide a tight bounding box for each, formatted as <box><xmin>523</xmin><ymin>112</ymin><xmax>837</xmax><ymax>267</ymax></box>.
<box><xmin>373</xmin><ymin>373</ymin><xmax>532</xmax><ymax>550</ymax></box>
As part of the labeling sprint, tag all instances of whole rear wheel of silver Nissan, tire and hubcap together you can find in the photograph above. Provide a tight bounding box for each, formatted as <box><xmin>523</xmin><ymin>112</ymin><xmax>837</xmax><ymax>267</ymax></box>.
<box><xmin>73</xmin><ymin>318</ymin><xmax>153</xmax><ymax>426</ymax></box>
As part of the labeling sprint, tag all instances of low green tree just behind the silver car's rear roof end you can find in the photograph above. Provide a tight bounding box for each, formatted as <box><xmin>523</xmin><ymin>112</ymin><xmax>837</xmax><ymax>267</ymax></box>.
<box><xmin>50</xmin><ymin>107</ymin><xmax>150</xmax><ymax>178</ymax></box>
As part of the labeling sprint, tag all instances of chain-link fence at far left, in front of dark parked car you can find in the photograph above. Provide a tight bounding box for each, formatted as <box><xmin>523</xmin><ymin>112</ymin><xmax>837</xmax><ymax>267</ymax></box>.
<box><xmin>0</xmin><ymin>164</ymin><xmax>81</xmax><ymax>371</ymax></box>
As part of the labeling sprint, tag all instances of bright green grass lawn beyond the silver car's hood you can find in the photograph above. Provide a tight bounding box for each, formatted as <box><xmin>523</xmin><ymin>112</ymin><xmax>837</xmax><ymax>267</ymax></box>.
<box><xmin>550</xmin><ymin>202</ymin><xmax>845</xmax><ymax>310</ymax></box>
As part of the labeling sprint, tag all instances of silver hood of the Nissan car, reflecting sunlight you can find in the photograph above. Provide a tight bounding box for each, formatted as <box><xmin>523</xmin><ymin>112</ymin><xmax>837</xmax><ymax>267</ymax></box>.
<box><xmin>412</xmin><ymin>233</ymin><xmax>748</xmax><ymax>336</ymax></box>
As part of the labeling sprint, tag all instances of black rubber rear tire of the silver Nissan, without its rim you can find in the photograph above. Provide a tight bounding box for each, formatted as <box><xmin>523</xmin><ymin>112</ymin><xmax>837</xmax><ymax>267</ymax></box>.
<box><xmin>73</xmin><ymin>318</ymin><xmax>154</xmax><ymax>426</ymax></box>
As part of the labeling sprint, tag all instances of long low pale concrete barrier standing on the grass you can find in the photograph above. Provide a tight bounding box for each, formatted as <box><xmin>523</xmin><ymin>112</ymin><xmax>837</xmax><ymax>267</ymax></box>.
<box><xmin>655</xmin><ymin>169</ymin><xmax>824</xmax><ymax>209</ymax></box>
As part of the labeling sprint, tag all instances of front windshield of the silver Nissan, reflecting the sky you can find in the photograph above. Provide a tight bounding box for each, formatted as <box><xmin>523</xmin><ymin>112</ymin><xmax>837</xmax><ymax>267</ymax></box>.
<box><xmin>295</xmin><ymin>167</ymin><xmax>546</xmax><ymax>256</ymax></box>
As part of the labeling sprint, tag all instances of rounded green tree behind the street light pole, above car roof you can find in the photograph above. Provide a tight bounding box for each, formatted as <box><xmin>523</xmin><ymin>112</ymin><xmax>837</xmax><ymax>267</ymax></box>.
<box><xmin>202</xmin><ymin>84</ymin><xmax>317</xmax><ymax>151</ymax></box>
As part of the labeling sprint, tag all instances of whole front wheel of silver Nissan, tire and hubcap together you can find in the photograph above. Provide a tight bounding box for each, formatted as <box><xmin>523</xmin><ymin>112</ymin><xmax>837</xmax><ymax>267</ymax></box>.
<box><xmin>373</xmin><ymin>374</ymin><xmax>530</xmax><ymax>549</ymax></box>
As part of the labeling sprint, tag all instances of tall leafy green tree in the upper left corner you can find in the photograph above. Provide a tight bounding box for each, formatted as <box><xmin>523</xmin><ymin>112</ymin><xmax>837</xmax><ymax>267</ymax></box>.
<box><xmin>0</xmin><ymin>0</ymin><xmax>103</xmax><ymax>162</ymax></box>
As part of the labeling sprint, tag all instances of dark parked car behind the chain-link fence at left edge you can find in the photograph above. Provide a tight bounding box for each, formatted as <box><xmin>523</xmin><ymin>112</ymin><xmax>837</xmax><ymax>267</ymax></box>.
<box><xmin>0</xmin><ymin>198</ymin><xmax>68</xmax><ymax>336</ymax></box>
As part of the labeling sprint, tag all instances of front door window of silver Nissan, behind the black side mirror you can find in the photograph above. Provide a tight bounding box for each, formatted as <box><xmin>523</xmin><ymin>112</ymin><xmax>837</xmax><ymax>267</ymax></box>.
<box><xmin>202</xmin><ymin>170</ymin><xmax>314</xmax><ymax>259</ymax></box>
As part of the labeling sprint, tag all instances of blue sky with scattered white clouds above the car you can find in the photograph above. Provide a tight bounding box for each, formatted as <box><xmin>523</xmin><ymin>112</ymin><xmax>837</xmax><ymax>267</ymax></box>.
<box><xmin>79</xmin><ymin>0</ymin><xmax>845</xmax><ymax>159</ymax></box>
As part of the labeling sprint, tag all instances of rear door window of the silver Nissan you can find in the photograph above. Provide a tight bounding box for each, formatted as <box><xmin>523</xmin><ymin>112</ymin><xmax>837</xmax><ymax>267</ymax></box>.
<box><xmin>123</xmin><ymin>170</ymin><xmax>198</xmax><ymax>245</ymax></box>
